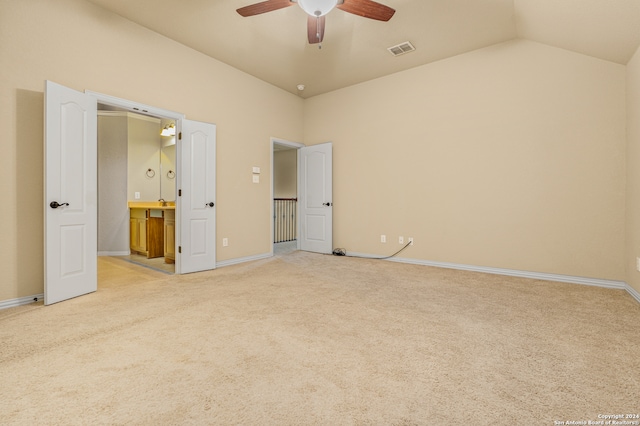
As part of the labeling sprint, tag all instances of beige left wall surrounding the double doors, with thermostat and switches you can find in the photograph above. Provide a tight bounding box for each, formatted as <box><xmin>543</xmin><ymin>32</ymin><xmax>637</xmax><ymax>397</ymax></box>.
<box><xmin>0</xmin><ymin>0</ymin><xmax>303</xmax><ymax>301</ymax></box>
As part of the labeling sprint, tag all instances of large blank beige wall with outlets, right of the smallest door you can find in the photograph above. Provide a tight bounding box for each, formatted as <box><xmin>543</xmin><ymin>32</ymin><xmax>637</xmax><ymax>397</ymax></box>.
<box><xmin>304</xmin><ymin>40</ymin><xmax>624</xmax><ymax>280</ymax></box>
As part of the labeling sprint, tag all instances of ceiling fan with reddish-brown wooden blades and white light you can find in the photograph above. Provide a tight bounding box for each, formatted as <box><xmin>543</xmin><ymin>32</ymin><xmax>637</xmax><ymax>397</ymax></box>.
<box><xmin>237</xmin><ymin>0</ymin><xmax>396</xmax><ymax>44</ymax></box>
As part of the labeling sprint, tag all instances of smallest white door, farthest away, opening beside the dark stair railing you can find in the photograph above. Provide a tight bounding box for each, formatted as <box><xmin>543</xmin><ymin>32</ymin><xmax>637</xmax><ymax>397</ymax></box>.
<box><xmin>298</xmin><ymin>142</ymin><xmax>333</xmax><ymax>253</ymax></box>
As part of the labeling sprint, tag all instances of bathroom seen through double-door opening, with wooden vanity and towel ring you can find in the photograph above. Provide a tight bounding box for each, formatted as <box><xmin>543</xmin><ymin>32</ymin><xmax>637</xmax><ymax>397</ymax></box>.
<box><xmin>97</xmin><ymin>103</ymin><xmax>177</xmax><ymax>274</ymax></box>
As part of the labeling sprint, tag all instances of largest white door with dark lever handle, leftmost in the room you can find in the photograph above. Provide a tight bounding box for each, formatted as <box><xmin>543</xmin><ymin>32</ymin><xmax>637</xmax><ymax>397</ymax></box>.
<box><xmin>44</xmin><ymin>81</ymin><xmax>98</xmax><ymax>305</ymax></box>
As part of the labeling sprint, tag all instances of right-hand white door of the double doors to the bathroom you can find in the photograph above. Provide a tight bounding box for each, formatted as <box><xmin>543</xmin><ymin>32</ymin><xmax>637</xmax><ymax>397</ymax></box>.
<box><xmin>176</xmin><ymin>120</ymin><xmax>216</xmax><ymax>274</ymax></box>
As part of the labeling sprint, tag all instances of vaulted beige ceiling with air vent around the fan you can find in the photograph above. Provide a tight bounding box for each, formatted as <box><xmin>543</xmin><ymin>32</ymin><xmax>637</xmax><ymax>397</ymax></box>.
<box><xmin>87</xmin><ymin>0</ymin><xmax>640</xmax><ymax>98</ymax></box>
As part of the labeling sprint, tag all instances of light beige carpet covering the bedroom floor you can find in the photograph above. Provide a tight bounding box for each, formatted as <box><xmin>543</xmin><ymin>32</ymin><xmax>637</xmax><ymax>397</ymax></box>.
<box><xmin>0</xmin><ymin>252</ymin><xmax>640</xmax><ymax>425</ymax></box>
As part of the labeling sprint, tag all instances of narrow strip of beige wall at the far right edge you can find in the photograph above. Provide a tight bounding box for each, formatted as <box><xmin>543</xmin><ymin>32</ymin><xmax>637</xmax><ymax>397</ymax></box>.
<box><xmin>626</xmin><ymin>48</ymin><xmax>640</xmax><ymax>292</ymax></box>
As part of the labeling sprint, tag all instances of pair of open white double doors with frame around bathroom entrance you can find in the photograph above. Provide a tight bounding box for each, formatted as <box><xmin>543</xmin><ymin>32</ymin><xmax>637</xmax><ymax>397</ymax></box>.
<box><xmin>44</xmin><ymin>81</ymin><xmax>216</xmax><ymax>305</ymax></box>
